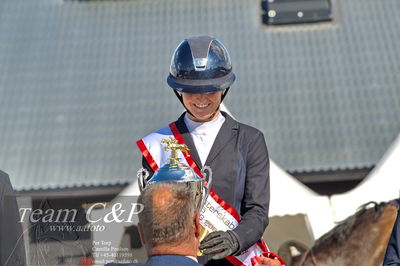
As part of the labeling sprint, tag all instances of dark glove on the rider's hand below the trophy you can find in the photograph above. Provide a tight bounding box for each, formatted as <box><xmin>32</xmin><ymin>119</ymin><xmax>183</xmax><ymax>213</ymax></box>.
<box><xmin>199</xmin><ymin>231</ymin><xmax>239</xmax><ymax>260</ymax></box>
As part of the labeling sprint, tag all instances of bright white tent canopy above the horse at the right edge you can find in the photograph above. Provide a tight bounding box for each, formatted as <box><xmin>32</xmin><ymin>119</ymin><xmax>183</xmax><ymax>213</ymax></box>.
<box><xmin>331</xmin><ymin>134</ymin><xmax>400</xmax><ymax>221</ymax></box>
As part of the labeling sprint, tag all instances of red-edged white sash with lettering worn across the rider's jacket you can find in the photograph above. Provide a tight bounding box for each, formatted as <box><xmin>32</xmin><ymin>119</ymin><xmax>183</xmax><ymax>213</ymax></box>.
<box><xmin>136</xmin><ymin>123</ymin><xmax>269</xmax><ymax>266</ymax></box>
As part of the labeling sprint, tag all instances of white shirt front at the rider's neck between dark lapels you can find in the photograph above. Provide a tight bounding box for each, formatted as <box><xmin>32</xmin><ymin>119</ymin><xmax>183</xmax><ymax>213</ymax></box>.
<box><xmin>184</xmin><ymin>113</ymin><xmax>225</xmax><ymax>165</ymax></box>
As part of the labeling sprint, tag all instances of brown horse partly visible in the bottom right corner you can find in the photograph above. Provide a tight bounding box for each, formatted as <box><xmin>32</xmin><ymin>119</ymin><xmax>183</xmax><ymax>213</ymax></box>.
<box><xmin>278</xmin><ymin>202</ymin><xmax>397</xmax><ymax>266</ymax></box>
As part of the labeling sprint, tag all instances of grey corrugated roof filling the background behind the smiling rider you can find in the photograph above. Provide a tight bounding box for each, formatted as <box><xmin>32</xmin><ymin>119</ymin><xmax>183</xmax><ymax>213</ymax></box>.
<box><xmin>0</xmin><ymin>0</ymin><xmax>400</xmax><ymax>190</ymax></box>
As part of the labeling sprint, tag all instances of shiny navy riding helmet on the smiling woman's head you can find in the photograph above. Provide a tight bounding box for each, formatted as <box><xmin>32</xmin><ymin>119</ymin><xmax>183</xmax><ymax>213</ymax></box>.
<box><xmin>167</xmin><ymin>36</ymin><xmax>235</xmax><ymax>99</ymax></box>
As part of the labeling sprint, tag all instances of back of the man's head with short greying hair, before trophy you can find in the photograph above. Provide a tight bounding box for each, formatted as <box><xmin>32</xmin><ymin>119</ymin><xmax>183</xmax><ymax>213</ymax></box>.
<box><xmin>138</xmin><ymin>181</ymin><xmax>196</xmax><ymax>248</ymax></box>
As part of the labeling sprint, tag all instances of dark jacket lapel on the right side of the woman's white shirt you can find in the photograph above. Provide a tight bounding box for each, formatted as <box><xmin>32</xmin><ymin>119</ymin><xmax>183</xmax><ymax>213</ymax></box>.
<box><xmin>205</xmin><ymin>111</ymin><xmax>239</xmax><ymax>165</ymax></box>
